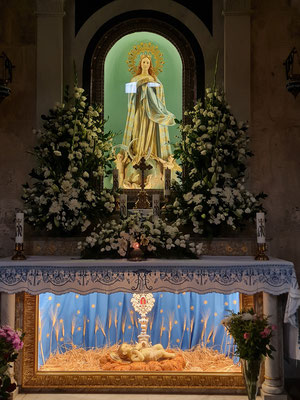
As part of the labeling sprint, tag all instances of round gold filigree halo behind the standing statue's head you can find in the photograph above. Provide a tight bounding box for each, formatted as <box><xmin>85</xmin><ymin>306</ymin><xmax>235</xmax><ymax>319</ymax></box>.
<box><xmin>126</xmin><ymin>42</ymin><xmax>164</xmax><ymax>75</ymax></box>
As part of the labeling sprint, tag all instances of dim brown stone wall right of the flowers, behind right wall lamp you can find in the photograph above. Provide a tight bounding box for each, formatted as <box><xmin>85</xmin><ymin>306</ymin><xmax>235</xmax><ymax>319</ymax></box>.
<box><xmin>250</xmin><ymin>0</ymin><xmax>300</xmax><ymax>281</ymax></box>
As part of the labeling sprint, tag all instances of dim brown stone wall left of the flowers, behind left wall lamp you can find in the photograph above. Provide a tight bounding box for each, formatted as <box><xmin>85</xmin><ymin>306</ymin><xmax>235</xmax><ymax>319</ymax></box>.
<box><xmin>0</xmin><ymin>0</ymin><xmax>36</xmax><ymax>256</ymax></box>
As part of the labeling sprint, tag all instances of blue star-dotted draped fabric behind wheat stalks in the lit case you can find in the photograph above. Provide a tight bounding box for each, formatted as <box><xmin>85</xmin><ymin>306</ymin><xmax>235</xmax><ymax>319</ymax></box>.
<box><xmin>39</xmin><ymin>292</ymin><xmax>239</xmax><ymax>366</ymax></box>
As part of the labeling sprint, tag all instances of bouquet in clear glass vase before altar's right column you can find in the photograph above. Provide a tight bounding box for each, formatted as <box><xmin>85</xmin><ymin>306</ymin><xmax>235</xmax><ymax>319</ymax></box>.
<box><xmin>222</xmin><ymin>309</ymin><xmax>276</xmax><ymax>400</ymax></box>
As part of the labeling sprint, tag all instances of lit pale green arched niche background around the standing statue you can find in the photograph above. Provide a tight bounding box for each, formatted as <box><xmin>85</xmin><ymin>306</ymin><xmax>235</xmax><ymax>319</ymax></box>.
<box><xmin>104</xmin><ymin>32</ymin><xmax>182</xmax><ymax>156</ymax></box>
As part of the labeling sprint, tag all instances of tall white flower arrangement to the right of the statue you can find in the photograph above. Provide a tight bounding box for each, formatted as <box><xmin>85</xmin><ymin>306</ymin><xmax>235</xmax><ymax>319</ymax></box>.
<box><xmin>166</xmin><ymin>88</ymin><xmax>265</xmax><ymax>236</ymax></box>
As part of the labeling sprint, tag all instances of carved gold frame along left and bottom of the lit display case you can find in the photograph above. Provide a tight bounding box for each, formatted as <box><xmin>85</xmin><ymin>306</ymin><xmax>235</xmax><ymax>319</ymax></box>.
<box><xmin>22</xmin><ymin>293</ymin><xmax>244</xmax><ymax>393</ymax></box>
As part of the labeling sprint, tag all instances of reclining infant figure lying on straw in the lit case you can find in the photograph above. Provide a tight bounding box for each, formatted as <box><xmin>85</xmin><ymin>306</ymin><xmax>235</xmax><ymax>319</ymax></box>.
<box><xmin>110</xmin><ymin>343</ymin><xmax>176</xmax><ymax>362</ymax></box>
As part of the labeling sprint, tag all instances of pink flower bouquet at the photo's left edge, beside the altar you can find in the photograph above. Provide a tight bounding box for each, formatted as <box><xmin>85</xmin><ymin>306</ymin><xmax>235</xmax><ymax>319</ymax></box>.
<box><xmin>0</xmin><ymin>325</ymin><xmax>24</xmax><ymax>399</ymax></box>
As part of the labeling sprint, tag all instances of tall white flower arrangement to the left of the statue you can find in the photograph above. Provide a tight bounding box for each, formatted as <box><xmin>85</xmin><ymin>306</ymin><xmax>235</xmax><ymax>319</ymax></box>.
<box><xmin>22</xmin><ymin>86</ymin><xmax>115</xmax><ymax>233</ymax></box>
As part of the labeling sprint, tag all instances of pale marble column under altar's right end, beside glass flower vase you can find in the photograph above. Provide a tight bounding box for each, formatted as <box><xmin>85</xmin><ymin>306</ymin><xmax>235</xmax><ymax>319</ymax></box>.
<box><xmin>261</xmin><ymin>293</ymin><xmax>287</xmax><ymax>400</ymax></box>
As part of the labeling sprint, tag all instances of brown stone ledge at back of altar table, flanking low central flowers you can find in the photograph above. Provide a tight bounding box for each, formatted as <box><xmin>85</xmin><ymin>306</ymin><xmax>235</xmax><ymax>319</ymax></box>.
<box><xmin>24</xmin><ymin>237</ymin><xmax>256</xmax><ymax>257</ymax></box>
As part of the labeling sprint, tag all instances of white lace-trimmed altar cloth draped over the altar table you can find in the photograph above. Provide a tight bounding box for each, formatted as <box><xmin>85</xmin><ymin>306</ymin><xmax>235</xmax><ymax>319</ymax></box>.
<box><xmin>0</xmin><ymin>256</ymin><xmax>300</xmax><ymax>325</ymax></box>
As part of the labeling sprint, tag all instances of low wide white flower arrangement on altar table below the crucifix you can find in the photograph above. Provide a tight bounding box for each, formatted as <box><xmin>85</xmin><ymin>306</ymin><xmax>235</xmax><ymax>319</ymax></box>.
<box><xmin>78</xmin><ymin>214</ymin><xmax>202</xmax><ymax>258</ymax></box>
